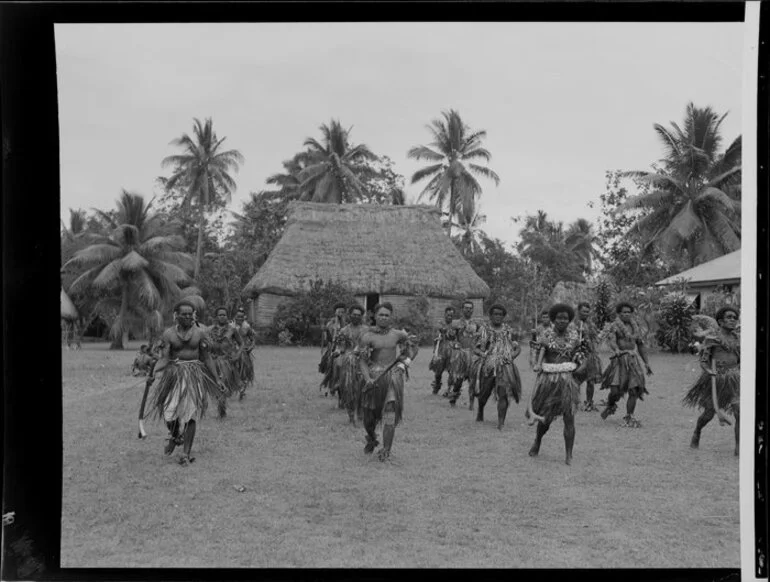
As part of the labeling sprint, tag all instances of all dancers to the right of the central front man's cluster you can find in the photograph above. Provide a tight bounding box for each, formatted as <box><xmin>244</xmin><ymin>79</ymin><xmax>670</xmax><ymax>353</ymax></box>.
<box><xmin>430</xmin><ymin>301</ymin><xmax>740</xmax><ymax>464</ymax></box>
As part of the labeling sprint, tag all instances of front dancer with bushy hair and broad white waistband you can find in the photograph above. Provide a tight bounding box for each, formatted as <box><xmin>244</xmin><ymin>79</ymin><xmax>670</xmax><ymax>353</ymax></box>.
<box><xmin>526</xmin><ymin>303</ymin><xmax>584</xmax><ymax>465</ymax></box>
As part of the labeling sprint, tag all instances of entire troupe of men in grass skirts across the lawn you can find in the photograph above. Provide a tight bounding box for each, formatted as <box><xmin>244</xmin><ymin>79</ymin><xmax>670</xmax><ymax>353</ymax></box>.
<box><xmin>140</xmin><ymin>300</ymin><xmax>740</xmax><ymax>465</ymax></box>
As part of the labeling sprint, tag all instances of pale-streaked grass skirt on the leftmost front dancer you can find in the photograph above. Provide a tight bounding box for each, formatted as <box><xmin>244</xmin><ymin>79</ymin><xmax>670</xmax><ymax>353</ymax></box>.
<box><xmin>145</xmin><ymin>360</ymin><xmax>221</xmax><ymax>425</ymax></box>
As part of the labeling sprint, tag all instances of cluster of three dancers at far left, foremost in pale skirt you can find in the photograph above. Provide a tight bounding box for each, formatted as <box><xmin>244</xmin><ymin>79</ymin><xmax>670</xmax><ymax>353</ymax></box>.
<box><xmin>140</xmin><ymin>299</ymin><xmax>255</xmax><ymax>465</ymax></box>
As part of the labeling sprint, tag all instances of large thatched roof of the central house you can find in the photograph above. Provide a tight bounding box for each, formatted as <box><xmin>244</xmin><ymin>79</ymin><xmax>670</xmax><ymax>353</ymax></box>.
<box><xmin>244</xmin><ymin>202</ymin><xmax>489</xmax><ymax>298</ymax></box>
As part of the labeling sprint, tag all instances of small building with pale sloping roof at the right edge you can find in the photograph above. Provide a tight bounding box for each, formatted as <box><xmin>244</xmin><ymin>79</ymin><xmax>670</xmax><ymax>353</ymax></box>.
<box><xmin>655</xmin><ymin>249</ymin><xmax>741</xmax><ymax>309</ymax></box>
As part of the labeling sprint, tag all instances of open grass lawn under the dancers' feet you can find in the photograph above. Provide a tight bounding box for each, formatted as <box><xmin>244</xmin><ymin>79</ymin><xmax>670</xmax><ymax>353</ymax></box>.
<box><xmin>61</xmin><ymin>343</ymin><xmax>740</xmax><ymax>568</ymax></box>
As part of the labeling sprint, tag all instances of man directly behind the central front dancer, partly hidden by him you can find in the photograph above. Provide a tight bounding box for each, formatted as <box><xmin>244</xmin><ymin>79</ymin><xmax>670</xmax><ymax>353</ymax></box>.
<box><xmin>333</xmin><ymin>305</ymin><xmax>369</xmax><ymax>425</ymax></box>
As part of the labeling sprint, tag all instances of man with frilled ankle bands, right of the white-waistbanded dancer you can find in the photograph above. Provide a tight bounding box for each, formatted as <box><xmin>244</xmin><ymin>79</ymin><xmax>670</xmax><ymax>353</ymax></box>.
<box><xmin>601</xmin><ymin>302</ymin><xmax>652</xmax><ymax>428</ymax></box>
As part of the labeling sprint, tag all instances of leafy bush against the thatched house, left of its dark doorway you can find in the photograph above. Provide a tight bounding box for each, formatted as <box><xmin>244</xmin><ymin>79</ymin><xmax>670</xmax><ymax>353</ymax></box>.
<box><xmin>270</xmin><ymin>279</ymin><xmax>355</xmax><ymax>345</ymax></box>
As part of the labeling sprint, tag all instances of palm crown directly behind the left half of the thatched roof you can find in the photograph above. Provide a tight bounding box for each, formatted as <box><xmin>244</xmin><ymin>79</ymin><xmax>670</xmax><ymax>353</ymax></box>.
<box><xmin>299</xmin><ymin>119</ymin><xmax>377</xmax><ymax>204</ymax></box>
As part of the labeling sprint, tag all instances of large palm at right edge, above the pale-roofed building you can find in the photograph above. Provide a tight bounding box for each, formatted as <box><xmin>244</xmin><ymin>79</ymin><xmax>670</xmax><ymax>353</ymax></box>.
<box><xmin>618</xmin><ymin>103</ymin><xmax>741</xmax><ymax>266</ymax></box>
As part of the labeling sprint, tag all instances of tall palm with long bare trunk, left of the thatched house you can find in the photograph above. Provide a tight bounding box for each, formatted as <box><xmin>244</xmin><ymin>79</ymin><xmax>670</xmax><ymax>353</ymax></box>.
<box><xmin>161</xmin><ymin>118</ymin><xmax>244</xmax><ymax>280</ymax></box>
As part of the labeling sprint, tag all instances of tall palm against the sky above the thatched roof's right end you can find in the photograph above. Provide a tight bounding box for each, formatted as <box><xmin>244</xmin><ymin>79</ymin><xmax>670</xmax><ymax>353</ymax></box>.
<box><xmin>407</xmin><ymin>109</ymin><xmax>500</xmax><ymax>234</ymax></box>
